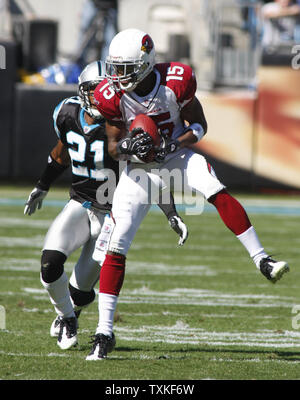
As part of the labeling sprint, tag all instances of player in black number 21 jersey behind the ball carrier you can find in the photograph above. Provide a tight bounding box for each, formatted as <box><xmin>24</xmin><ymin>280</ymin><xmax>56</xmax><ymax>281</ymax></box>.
<box><xmin>24</xmin><ymin>61</ymin><xmax>188</xmax><ymax>349</ymax></box>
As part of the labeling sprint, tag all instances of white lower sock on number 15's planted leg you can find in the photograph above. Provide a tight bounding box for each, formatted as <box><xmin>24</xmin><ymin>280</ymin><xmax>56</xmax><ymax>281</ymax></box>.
<box><xmin>96</xmin><ymin>293</ymin><xmax>118</xmax><ymax>337</ymax></box>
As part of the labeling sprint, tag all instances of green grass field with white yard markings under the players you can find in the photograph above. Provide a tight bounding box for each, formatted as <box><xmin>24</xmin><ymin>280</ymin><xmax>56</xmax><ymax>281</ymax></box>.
<box><xmin>0</xmin><ymin>187</ymin><xmax>300</xmax><ymax>380</ymax></box>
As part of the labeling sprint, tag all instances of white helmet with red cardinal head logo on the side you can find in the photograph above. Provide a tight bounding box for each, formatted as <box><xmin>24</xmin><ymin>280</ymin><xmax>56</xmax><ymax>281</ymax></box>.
<box><xmin>106</xmin><ymin>29</ymin><xmax>155</xmax><ymax>92</ymax></box>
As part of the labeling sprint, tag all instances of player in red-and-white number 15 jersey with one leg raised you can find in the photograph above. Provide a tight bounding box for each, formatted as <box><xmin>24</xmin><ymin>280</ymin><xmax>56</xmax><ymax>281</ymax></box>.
<box><xmin>86</xmin><ymin>29</ymin><xmax>288</xmax><ymax>360</ymax></box>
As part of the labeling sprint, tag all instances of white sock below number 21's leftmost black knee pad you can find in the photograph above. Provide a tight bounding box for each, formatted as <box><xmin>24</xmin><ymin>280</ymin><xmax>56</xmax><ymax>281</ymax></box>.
<box><xmin>41</xmin><ymin>272</ymin><xmax>75</xmax><ymax>318</ymax></box>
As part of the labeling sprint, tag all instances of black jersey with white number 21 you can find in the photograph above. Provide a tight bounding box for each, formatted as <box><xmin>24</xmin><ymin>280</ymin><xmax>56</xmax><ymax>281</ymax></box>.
<box><xmin>53</xmin><ymin>96</ymin><xmax>119</xmax><ymax>210</ymax></box>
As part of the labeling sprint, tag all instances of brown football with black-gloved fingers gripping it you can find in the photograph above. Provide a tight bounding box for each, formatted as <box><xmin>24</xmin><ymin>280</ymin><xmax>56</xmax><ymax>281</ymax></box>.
<box><xmin>129</xmin><ymin>114</ymin><xmax>161</xmax><ymax>163</ymax></box>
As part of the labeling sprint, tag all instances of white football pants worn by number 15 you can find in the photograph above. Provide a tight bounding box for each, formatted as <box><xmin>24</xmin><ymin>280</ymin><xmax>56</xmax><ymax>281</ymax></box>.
<box><xmin>108</xmin><ymin>149</ymin><xmax>225</xmax><ymax>255</ymax></box>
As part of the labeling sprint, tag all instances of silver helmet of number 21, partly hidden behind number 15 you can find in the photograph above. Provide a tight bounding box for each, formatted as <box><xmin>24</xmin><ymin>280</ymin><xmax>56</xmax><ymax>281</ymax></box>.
<box><xmin>78</xmin><ymin>61</ymin><xmax>105</xmax><ymax>119</ymax></box>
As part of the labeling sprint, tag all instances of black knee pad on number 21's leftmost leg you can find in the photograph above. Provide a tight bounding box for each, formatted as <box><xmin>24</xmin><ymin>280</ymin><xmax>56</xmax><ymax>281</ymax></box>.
<box><xmin>41</xmin><ymin>250</ymin><xmax>67</xmax><ymax>283</ymax></box>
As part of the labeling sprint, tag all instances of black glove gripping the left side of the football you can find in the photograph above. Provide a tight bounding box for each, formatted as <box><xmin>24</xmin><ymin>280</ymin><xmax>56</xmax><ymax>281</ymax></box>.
<box><xmin>117</xmin><ymin>128</ymin><xmax>153</xmax><ymax>158</ymax></box>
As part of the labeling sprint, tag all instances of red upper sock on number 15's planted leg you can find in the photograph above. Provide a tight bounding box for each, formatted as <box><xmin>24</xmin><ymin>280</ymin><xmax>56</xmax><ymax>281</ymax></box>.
<box><xmin>100</xmin><ymin>254</ymin><xmax>126</xmax><ymax>296</ymax></box>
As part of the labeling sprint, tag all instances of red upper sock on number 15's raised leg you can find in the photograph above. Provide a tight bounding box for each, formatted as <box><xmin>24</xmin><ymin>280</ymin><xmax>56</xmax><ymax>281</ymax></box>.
<box><xmin>208</xmin><ymin>189</ymin><xmax>251</xmax><ymax>235</ymax></box>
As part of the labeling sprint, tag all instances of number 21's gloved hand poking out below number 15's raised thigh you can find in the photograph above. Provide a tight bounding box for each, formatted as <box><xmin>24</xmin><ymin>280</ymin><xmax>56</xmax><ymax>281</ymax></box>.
<box><xmin>157</xmin><ymin>193</ymin><xmax>188</xmax><ymax>246</ymax></box>
